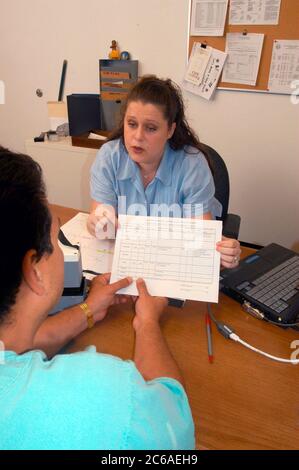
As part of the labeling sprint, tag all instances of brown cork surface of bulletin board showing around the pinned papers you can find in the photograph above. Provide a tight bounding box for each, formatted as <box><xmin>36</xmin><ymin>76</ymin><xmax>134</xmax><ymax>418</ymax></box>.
<box><xmin>189</xmin><ymin>0</ymin><xmax>299</xmax><ymax>92</ymax></box>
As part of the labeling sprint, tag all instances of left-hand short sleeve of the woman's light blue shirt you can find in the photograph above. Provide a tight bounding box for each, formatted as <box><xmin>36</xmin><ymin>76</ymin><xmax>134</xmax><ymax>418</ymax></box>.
<box><xmin>90</xmin><ymin>143</ymin><xmax>117</xmax><ymax>209</ymax></box>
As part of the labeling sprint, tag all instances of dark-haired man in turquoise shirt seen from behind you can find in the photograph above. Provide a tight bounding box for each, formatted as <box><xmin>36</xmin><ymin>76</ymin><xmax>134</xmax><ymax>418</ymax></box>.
<box><xmin>0</xmin><ymin>147</ymin><xmax>194</xmax><ymax>450</ymax></box>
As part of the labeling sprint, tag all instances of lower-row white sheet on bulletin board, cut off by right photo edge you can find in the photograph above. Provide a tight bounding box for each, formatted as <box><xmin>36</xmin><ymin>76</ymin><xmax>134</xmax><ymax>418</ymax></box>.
<box><xmin>268</xmin><ymin>41</ymin><xmax>299</xmax><ymax>94</ymax></box>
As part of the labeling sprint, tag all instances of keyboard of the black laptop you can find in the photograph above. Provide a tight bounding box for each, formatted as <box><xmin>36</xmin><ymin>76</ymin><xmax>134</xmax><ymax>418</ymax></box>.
<box><xmin>238</xmin><ymin>255</ymin><xmax>299</xmax><ymax>313</ymax></box>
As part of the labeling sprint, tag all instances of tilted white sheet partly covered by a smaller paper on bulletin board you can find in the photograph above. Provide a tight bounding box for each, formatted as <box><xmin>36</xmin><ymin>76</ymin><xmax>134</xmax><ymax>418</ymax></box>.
<box><xmin>182</xmin><ymin>42</ymin><xmax>227</xmax><ymax>100</ymax></box>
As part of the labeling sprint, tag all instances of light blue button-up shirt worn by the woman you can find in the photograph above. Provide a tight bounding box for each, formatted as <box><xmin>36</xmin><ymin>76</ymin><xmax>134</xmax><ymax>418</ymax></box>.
<box><xmin>90</xmin><ymin>139</ymin><xmax>222</xmax><ymax>217</ymax></box>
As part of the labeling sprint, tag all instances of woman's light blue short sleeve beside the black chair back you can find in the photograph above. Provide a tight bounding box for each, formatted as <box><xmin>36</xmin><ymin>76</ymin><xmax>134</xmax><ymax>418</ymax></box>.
<box><xmin>182</xmin><ymin>153</ymin><xmax>222</xmax><ymax>217</ymax></box>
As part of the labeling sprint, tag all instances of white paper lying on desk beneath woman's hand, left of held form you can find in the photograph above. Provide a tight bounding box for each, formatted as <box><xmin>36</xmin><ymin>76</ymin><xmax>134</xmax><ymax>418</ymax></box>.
<box><xmin>61</xmin><ymin>212</ymin><xmax>114</xmax><ymax>279</ymax></box>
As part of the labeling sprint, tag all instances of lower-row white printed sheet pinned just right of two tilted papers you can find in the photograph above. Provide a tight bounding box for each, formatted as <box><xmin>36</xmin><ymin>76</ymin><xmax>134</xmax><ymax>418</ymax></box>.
<box><xmin>222</xmin><ymin>33</ymin><xmax>264</xmax><ymax>85</ymax></box>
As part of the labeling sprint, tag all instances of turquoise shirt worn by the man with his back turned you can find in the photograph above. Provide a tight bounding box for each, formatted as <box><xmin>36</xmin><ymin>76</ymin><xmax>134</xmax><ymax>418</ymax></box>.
<box><xmin>0</xmin><ymin>347</ymin><xmax>194</xmax><ymax>450</ymax></box>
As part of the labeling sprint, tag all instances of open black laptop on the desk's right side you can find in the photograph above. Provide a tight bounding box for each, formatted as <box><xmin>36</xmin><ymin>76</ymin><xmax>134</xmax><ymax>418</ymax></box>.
<box><xmin>220</xmin><ymin>243</ymin><xmax>299</xmax><ymax>325</ymax></box>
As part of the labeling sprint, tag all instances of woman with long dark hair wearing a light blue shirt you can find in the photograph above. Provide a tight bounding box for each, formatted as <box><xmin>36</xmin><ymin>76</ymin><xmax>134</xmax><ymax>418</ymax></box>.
<box><xmin>87</xmin><ymin>75</ymin><xmax>241</xmax><ymax>268</ymax></box>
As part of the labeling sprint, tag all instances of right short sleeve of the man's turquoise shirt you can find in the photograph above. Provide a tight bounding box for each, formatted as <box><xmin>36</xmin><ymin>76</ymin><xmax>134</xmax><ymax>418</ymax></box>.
<box><xmin>127</xmin><ymin>371</ymin><xmax>195</xmax><ymax>450</ymax></box>
